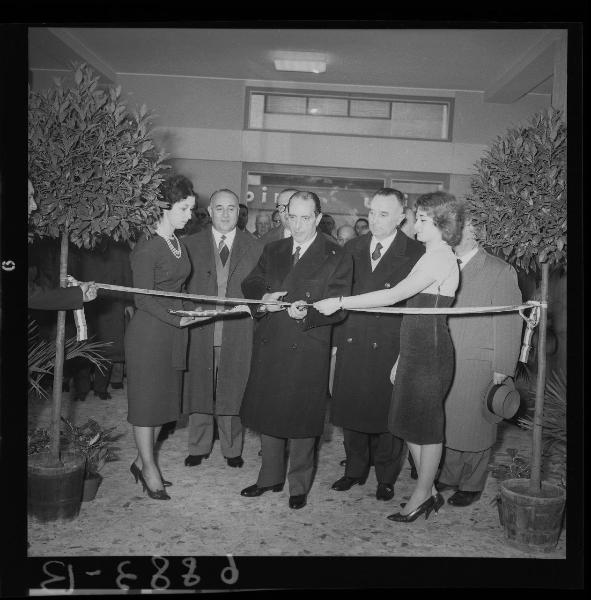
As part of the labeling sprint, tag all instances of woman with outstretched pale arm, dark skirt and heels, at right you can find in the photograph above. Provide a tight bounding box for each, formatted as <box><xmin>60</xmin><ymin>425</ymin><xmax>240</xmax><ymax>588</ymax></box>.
<box><xmin>314</xmin><ymin>192</ymin><xmax>464</xmax><ymax>522</ymax></box>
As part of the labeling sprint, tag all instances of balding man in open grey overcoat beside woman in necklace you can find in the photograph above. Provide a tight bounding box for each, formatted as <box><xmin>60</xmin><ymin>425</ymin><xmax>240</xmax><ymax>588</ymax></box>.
<box><xmin>183</xmin><ymin>189</ymin><xmax>262</xmax><ymax>467</ymax></box>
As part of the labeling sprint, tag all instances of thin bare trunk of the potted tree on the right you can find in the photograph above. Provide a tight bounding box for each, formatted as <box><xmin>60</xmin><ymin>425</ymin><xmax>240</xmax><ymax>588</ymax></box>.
<box><xmin>529</xmin><ymin>262</ymin><xmax>549</xmax><ymax>495</ymax></box>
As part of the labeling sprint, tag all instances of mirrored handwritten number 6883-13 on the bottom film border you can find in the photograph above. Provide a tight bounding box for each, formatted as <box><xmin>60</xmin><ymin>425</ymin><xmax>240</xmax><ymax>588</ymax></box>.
<box><xmin>41</xmin><ymin>554</ymin><xmax>240</xmax><ymax>594</ymax></box>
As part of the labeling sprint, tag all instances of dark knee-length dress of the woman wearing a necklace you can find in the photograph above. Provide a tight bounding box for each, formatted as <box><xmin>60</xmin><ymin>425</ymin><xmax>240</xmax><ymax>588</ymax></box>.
<box><xmin>125</xmin><ymin>235</ymin><xmax>191</xmax><ymax>427</ymax></box>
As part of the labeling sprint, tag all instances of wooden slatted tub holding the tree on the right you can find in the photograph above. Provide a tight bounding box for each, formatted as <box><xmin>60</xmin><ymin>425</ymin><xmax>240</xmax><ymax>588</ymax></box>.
<box><xmin>500</xmin><ymin>479</ymin><xmax>566</xmax><ymax>552</ymax></box>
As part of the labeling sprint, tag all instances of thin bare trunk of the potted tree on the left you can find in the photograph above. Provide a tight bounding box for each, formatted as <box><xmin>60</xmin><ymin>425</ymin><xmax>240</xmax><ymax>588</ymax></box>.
<box><xmin>50</xmin><ymin>231</ymin><xmax>68</xmax><ymax>465</ymax></box>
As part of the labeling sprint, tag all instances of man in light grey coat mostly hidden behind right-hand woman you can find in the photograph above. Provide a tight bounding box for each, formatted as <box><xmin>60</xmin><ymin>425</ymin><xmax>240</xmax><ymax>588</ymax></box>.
<box><xmin>438</xmin><ymin>219</ymin><xmax>523</xmax><ymax>506</ymax></box>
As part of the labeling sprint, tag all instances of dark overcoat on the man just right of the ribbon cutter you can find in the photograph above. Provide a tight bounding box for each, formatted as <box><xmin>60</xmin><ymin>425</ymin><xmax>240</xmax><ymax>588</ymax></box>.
<box><xmin>331</xmin><ymin>230</ymin><xmax>425</xmax><ymax>433</ymax></box>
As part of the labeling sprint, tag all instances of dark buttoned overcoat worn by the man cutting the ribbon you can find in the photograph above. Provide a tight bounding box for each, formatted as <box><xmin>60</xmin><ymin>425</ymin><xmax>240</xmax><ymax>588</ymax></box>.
<box><xmin>240</xmin><ymin>234</ymin><xmax>352</xmax><ymax>438</ymax></box>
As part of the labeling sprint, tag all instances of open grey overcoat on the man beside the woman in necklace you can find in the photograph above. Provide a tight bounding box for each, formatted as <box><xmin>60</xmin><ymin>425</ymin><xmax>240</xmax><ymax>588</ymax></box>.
<box><xmin>183</xmin><ymin>226</ymin><xmax>262</xmax><ymax>415</ymax></box>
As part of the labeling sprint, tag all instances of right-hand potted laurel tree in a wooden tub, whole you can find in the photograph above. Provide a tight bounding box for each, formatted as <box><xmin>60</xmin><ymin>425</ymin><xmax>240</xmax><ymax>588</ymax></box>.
<box><xmin>468</xmin><ymin>108</ymin><xmax>567</xmax><ymax>551</ymax></box>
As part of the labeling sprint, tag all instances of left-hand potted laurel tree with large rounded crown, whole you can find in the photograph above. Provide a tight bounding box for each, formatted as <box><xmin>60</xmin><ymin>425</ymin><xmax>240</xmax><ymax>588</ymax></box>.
<box><xmin>28</xmin><ymin>64</ymin><xmax>167</xmax><ymax>521</ymax></box>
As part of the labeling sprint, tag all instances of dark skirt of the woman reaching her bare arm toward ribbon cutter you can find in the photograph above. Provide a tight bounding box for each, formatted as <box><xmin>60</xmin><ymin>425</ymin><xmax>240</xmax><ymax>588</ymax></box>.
<box><xmin>388</xmin><ymin>293</ymin><xmax>454</xmax><ymax>445</ymax></box>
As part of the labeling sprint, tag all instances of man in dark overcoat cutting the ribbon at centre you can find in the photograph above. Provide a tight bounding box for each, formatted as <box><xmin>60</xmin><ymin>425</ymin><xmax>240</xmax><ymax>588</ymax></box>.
<box><xmin>240</xmin><ymin>192</ymin><xmax>352</xmax><ymax>509</ymax></box>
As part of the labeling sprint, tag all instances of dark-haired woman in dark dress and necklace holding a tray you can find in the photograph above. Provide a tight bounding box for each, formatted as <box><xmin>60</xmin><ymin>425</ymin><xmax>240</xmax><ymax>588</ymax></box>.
<box><xmin>125</xmin><ymin>175</ymin><xmax>204</xmax><ymax>500</ymax></box>
